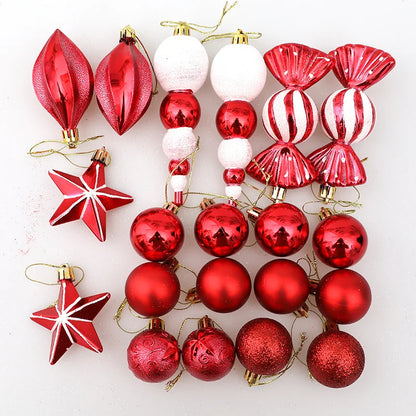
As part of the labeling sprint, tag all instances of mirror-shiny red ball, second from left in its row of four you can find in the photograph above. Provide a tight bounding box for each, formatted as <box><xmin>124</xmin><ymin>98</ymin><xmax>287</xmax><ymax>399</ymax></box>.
<box><xmin>194</xmin><ymin>204</ymin><xmax>248</xmax><ymax>257</ymax></box>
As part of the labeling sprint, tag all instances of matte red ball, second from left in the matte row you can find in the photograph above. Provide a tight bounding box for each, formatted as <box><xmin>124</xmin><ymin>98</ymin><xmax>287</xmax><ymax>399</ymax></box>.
<box><xmin>196</xmin><ymin>258</ymin><xmax>251</xmax><ymax>313</ymax></box>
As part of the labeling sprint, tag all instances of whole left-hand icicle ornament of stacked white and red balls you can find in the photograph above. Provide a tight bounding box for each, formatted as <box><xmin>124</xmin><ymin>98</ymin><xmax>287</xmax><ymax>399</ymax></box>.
<box><xmin>154</xmin><ymin>23</ymin><xmax>209</xmax><ymax>206</ymax></box>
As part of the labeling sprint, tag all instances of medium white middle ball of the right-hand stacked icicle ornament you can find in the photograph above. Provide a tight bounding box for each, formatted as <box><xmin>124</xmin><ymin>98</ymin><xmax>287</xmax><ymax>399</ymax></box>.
<box><xmin>218</xmin><ymin>138</ymin><xmax>253</xmax><ymax>169</ymax></box>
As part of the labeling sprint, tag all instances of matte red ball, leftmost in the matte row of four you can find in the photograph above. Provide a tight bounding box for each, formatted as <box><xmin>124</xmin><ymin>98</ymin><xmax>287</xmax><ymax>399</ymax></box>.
<box><xmin>125</xmin><ymin>262</ymin><xmax>180</xmax><ymax>317</ymax></box>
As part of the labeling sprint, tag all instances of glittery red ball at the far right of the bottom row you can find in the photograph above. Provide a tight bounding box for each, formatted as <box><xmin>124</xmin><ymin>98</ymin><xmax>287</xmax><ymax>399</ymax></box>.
<box><xmin>306</xmin><ymin>330</ymin><xmax>365</xmax><ymax>388</ymax></box>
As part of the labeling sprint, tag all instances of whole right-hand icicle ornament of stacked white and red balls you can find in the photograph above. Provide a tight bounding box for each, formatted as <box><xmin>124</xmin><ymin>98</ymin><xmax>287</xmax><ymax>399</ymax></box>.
<box><xmin>211</xmin><ymin>29</ymin><xmax>267</xmax><ymax>204</ymax></box>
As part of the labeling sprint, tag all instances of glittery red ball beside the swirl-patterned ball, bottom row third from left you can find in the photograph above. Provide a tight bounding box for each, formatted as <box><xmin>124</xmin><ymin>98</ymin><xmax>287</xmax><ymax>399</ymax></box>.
<box><xmin>235</xmin><ymin>318</ymin><xmax>293</xmax><ymax>376</ymax></box>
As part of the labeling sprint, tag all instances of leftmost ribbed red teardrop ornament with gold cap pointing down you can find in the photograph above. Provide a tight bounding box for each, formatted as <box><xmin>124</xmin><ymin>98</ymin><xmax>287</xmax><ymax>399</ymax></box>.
<box><xmin>32</xmin><ymin>29</ymin><xmax>93</xmax><ymax>145</ymax></box>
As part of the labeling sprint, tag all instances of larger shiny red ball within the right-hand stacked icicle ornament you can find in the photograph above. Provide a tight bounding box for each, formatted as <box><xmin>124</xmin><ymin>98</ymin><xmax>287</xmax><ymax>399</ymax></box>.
<box><xmin>215</xmin><ymin>100</ymin><xmax>257</xmax><ymax>139</ymax></box>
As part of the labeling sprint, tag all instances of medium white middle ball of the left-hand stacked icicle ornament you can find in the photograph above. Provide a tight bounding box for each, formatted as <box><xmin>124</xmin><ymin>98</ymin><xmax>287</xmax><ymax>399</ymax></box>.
<box><xmin>162</xmin><ymin>127</ymin><xmax>197</xmax><ymax>160</ymax></box>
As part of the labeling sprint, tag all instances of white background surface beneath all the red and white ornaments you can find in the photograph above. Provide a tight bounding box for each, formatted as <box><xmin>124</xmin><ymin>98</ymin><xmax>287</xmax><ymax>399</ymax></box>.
<box><xmin>0</xmin><ymin>0</ymin><xmax>416</xmax><ymax>416</ymax></box>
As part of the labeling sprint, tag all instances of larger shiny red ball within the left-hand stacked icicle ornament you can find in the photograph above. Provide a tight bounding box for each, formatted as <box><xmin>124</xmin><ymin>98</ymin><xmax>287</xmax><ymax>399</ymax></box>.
<box><xmin>160</xmin><ymin>90</ymin><xmax>201</xmax><ymax>129</ymax></box>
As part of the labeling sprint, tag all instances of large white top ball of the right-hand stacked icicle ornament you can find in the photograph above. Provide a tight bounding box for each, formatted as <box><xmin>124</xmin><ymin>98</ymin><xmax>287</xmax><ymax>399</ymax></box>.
<box><xmin>211</xmin><ymin>43</ymin><xmax>267</xmax><ymax>102</ymax></box>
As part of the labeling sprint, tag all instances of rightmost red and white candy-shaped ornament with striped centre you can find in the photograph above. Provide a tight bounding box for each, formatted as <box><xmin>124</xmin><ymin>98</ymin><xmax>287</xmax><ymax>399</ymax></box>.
<box><xmin>309</xmin><ymin>44</ymin><xmax>395</xmax><ymax>198</ymax></box>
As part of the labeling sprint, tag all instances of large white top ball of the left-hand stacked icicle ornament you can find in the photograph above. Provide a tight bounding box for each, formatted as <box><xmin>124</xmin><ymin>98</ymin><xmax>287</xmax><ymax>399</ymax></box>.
<box><xmin>153</xmin><ymin>35</ymin><xmax>209</xmax><ymax>92</ymax></box>
